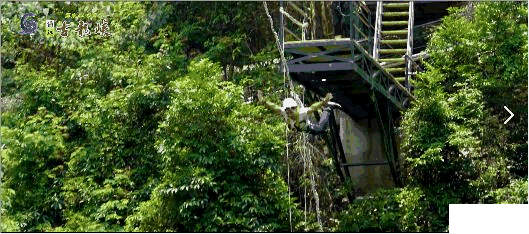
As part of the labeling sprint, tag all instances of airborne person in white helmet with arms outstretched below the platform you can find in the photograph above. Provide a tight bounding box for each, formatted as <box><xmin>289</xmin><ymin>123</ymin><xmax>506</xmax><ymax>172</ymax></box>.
<box><xmin>257</xmin><ymin>90</ymin><xmax>340</xmax><ymax>135</ymax></box>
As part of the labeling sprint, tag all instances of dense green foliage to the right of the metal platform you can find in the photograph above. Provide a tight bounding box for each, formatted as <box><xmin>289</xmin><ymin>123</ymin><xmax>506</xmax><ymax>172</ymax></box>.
<box><xmin>341</xmin><ymin>2</ymin><xmax>528</xmax><ymax>232</ymax></box>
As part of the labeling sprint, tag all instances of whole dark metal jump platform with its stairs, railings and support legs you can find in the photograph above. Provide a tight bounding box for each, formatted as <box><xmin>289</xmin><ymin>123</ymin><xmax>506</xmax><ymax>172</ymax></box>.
<box><xmin>272</xmin><ymin>1</ymin><xmax>416</xmax><ymax>199</ymax></box>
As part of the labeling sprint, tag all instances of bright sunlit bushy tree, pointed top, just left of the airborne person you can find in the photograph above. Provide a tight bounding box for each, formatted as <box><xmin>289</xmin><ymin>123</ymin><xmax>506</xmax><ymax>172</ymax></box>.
<box><xmin>127</xmin><ymin>60</ymin><xmax>292</xmax><ymax>231</ymax></box>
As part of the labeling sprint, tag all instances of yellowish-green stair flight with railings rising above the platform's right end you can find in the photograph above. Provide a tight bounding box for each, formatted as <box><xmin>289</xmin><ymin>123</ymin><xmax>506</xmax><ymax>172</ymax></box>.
<box><xmin>373</xmin><ymin>1</ymin><xmax>415</xmax><ymax>88</ymax></box>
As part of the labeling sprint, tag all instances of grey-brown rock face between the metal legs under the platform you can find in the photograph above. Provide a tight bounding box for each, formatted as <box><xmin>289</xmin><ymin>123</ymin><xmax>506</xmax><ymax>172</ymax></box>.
<box><xmin>335</xmin><ymin>110</ymin><xmax>395</xmax><ymax>196</ymax></box>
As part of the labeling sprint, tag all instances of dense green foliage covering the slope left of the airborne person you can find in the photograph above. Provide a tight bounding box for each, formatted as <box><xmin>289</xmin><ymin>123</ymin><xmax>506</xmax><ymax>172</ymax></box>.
<box><xmin>2</xmin><ymin>3</ymin><xmax>302</xmax><ymax>231</ymax></box>
